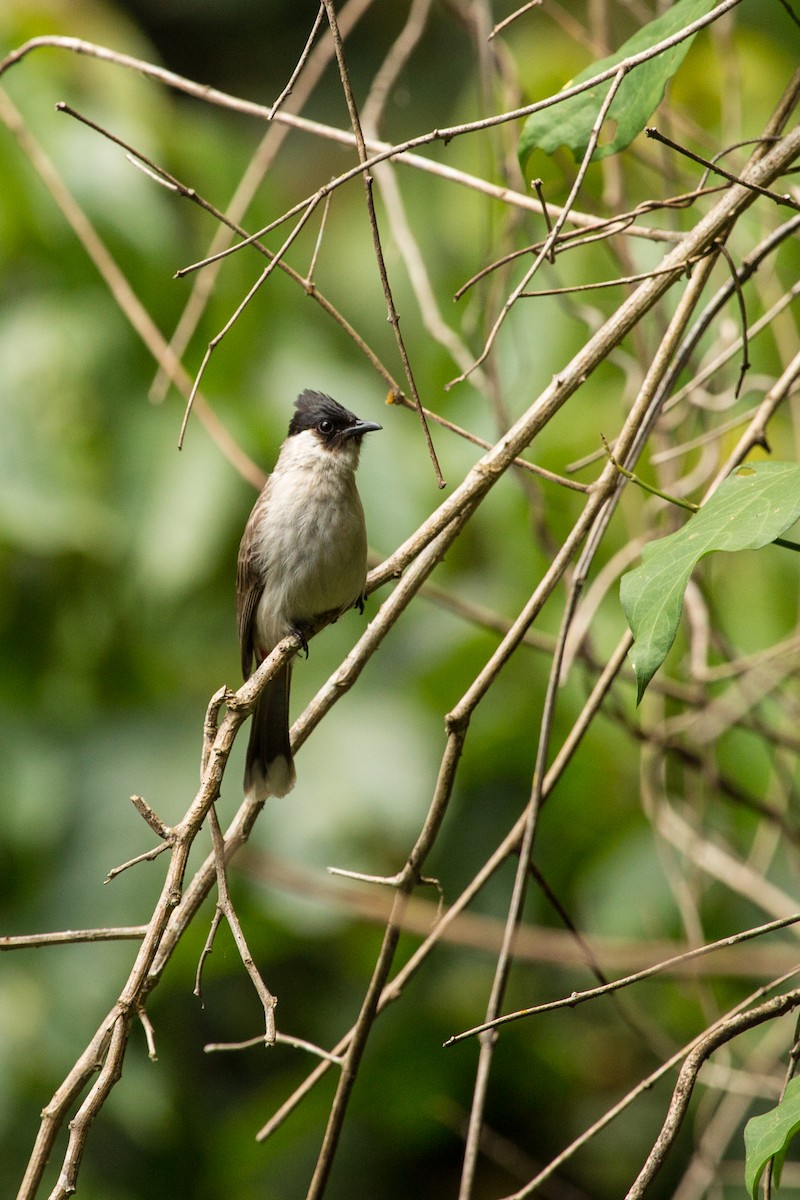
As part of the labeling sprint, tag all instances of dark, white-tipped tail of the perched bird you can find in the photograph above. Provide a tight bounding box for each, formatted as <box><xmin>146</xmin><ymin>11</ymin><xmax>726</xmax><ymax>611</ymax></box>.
<box><xmin>245</xmin><ymin>664</ymin><xmax>295</xmax><ymax>802</ymax></box>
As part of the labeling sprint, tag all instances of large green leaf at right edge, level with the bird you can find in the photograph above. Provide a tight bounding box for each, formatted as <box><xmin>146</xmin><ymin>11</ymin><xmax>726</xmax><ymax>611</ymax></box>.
<box><xmin>620</xmin><ymin>462</ymin><xmax>800</xmax><ymax>703</ymax></box>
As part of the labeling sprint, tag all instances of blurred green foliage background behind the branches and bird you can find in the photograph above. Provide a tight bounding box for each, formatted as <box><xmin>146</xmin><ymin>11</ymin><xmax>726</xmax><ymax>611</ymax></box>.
<box><xmin>0</xmin><ymin>0</ymin><xmax>799</xmax><ymax>1200</ymax></box>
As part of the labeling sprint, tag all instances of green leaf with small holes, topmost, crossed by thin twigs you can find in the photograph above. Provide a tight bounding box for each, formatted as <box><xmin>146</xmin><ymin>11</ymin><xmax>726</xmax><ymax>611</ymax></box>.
<box><xmin>518</xmin><ymin>0</ymin><xmax>714</xmax><ymax>170</ymax></box>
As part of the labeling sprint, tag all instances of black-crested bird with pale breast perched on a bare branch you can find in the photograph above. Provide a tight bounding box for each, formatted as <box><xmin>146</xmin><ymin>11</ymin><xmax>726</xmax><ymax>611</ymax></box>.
<box><xmin>236</xmin><ymin>389</ymin><xmax>381</xmax><ymax>803</ymax></box>
